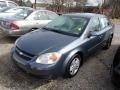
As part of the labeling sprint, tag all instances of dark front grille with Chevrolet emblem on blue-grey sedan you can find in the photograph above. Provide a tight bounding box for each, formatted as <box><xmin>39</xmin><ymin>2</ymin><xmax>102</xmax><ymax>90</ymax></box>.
<box><xmin>15</xmin><ymin>47</ymin><xmax>34</xmax><ymax>61</ymax></box>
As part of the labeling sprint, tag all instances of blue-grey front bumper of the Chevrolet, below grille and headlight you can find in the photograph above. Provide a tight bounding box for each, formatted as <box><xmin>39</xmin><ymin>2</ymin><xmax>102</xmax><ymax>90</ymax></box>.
<box><xmin>11</xmin><ymin>48</ymin><xmax>61</xmax><ymax>77</ymax></box>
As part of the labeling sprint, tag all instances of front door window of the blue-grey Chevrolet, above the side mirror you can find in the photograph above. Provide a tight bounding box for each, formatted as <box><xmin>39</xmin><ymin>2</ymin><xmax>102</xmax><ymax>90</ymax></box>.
<box><xmin>91</xmin><ymin>18</ymin><xmax>101</xmax><ymax>32</ymax></box>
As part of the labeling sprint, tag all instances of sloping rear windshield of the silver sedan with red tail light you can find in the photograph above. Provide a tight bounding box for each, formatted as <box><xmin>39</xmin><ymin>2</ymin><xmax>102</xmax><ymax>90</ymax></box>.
<box><xmin>14</xmin><ymin>10</ymin><xmax>33</xmax><ymax>19</ymax></box>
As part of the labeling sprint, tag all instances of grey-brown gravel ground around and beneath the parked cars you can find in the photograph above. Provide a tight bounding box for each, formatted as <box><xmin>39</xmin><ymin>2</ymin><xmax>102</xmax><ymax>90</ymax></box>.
<box><xmin>0</xmin><ymin>25</ymin><xmax>120</xmax><ymax>90</ymax></box>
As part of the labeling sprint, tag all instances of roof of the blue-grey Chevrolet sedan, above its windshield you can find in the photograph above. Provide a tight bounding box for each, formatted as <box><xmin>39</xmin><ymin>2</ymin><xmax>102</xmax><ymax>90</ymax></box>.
<box><xmin>64</xmin><ymin>13</ymin><xmax>105</xmax><ymax>19</ymax></box>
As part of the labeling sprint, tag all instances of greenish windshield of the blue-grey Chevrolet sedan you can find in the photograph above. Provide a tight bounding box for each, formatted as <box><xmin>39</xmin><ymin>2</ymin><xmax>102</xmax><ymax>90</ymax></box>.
<box><xmin>45</xmin><ymin>16</ymin><xmax>88</xmax><ymax>36</ymax></box>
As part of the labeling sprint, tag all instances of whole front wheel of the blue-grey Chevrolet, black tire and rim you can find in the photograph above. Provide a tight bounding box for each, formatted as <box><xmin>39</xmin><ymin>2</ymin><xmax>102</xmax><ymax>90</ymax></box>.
<box><xmin>64</xmin><ymin>54</ymin><xmax>82</xmax><ymax>78</ymax></box>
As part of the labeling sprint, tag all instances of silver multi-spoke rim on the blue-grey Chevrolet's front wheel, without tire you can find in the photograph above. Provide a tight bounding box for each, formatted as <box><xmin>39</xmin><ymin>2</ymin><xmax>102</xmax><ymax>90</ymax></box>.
<box><xmin>69</xmin><ymin>58</ymin><xmax>80</xmax><ymax>75</ymax></box>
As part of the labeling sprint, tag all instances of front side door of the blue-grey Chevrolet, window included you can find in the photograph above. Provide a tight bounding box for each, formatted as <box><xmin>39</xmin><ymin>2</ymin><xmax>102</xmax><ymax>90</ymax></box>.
<box><xmin>87</xmin><ymin>17</ymin><xmax>104</xmax><ymax>53</ymax></box>
